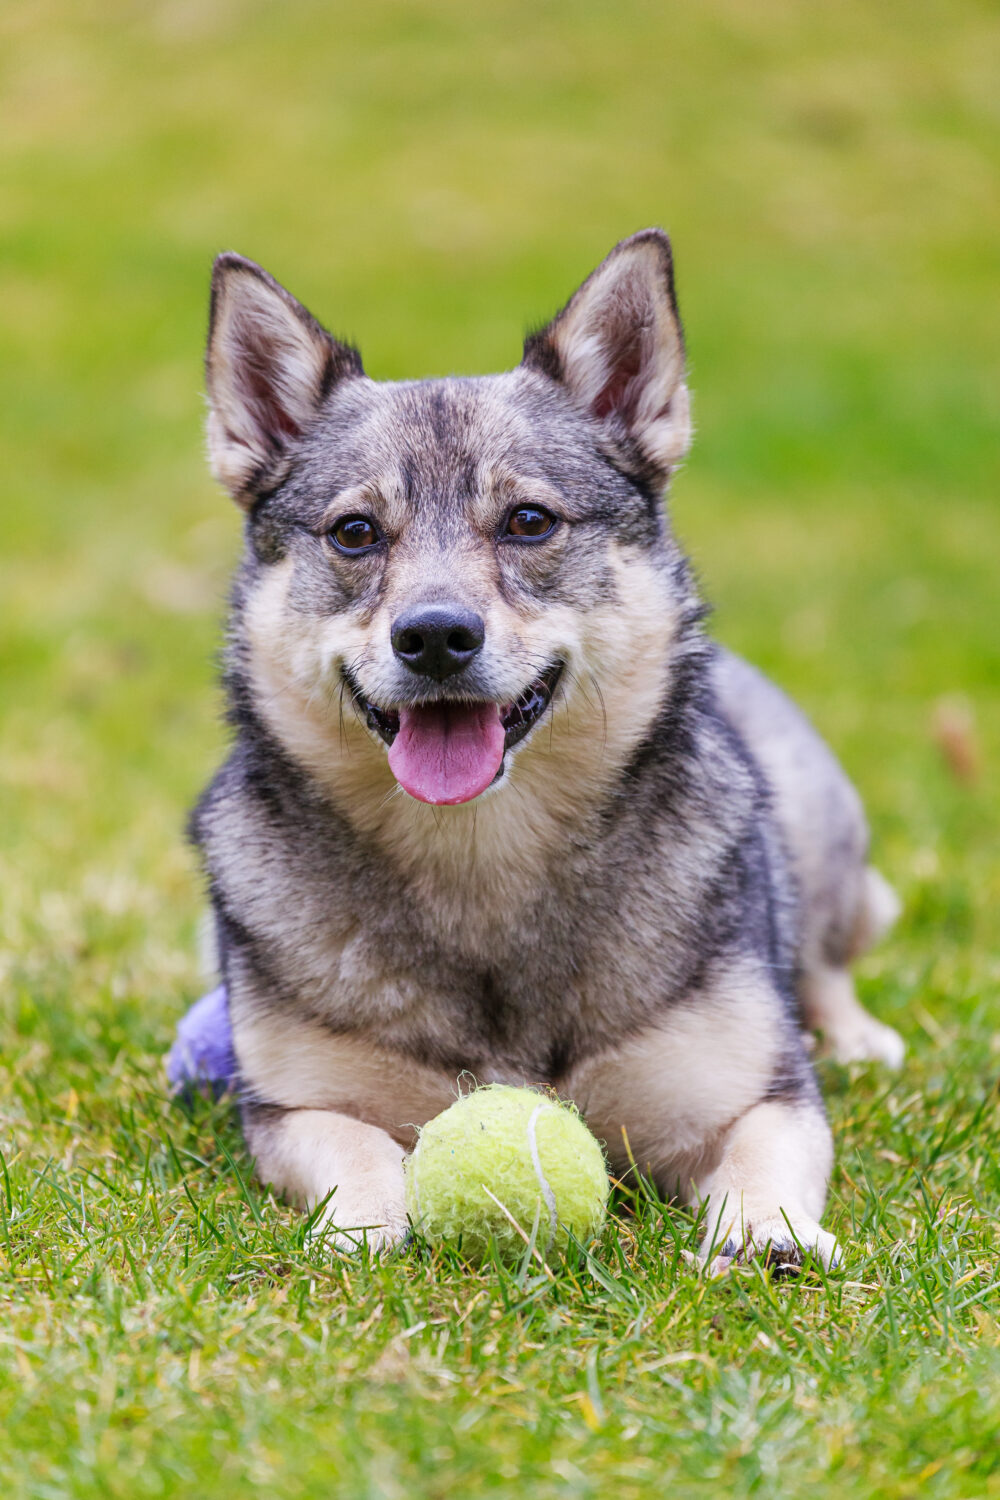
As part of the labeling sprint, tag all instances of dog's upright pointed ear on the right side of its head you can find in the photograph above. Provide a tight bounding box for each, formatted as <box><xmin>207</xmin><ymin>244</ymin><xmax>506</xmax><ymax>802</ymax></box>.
<box><xmin>523</xmin><ymin>230</ymin><xmax>691</xmax><ymax>488</ymax></box>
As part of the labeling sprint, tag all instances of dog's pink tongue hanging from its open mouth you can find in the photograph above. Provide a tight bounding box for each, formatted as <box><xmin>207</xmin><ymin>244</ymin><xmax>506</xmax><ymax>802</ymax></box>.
<box><xmin>388</xmin><ymin>704</ymin><xmax>504</xmax><ymax>804</ymax></box>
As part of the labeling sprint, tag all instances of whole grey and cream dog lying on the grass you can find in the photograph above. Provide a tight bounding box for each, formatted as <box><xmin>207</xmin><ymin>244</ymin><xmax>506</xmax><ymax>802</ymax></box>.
<box><xmin>193</xmin><ymin>230</ymin><xmax>903</xmax><ymax>1265</ymax></box>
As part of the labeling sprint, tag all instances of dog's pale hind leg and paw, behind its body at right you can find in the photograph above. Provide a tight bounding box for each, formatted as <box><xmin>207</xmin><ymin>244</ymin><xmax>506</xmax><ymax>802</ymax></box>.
<box><xmin>799</xmin><ymin>866</ymin><xmax>906</xmax><ymax>1068</ymax></box>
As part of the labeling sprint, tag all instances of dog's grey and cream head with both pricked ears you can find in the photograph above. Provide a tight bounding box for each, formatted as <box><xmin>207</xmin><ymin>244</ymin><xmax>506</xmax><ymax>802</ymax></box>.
<box><xmin>207</xmin><ymin>231</ymin><xmax>690</xmax><ymax>804</ymax></box>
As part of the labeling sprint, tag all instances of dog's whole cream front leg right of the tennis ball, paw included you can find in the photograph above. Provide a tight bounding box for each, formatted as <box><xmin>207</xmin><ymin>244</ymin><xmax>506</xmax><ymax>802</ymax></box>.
<box><xmin>562</xmin><ymin>962</ymin><xmax>837</xmax><ymax>1265</ymax></box>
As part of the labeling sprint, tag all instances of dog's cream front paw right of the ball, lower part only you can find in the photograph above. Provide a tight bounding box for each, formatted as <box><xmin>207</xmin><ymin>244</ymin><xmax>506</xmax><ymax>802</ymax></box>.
<box><xmin>694</xmin><ymin>1098</ymin><xmax>838</xmax><ymax>1269</ymax></box>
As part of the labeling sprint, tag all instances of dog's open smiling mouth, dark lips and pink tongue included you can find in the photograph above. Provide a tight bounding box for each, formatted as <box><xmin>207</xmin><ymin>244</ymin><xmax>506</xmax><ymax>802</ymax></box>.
<box><xmin>345</xmin><ymin>662</ymin><xmax>562</xmax><ymax>806</ymax></box>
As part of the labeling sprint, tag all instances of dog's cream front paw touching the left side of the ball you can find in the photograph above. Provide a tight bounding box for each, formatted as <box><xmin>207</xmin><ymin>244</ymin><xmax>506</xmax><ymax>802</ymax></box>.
<box><xmin>243</xmin><ymin>1104</ymin><xmax>406</xmax><ymax>1250</ymax></box>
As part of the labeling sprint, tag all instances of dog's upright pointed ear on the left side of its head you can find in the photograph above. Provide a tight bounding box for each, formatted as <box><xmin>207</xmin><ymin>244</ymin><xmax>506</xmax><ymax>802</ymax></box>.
<box><xmin>205</xmin><ymin>252</ymin><xmax>364</xmax><ymax>506</ymax></box>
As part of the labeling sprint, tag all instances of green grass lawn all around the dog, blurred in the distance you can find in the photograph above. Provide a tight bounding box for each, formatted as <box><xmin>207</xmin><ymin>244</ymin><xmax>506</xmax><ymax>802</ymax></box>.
<box><xmin>0</xmin><ymin>0</ymin><xmax>1000</xmax><ymax>1500</ymax></box>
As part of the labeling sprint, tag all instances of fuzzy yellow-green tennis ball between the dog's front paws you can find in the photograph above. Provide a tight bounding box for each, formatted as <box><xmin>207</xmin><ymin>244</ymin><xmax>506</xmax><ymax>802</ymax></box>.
<box><xmin>405</xmin><ymin>1083</ymin><xmax>610</xmax><ymax>1260</ymax></box>
